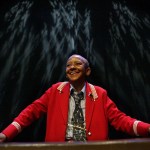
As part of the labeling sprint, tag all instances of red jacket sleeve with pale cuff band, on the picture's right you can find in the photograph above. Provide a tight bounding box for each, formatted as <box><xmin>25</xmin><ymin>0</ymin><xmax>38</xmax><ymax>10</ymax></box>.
<box><xmin>103</xmin><ymin>92</ymin><xmax>150</xmax><ymax>137</ymax></box>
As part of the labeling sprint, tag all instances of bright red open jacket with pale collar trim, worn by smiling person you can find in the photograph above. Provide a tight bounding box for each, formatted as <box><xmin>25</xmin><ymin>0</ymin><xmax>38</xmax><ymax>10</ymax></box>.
<box><xmin>2</xmin><ymin>82</ymin><xmax>150</xmax><ymax>142</ymax></box>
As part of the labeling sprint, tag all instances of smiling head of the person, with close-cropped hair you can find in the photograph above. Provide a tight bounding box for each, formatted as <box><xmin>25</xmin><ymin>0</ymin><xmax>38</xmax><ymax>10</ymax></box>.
<box><xmin>66</xmin><ymin>55</ymin><xmax>91</xmax><ymax>85</ymax></box>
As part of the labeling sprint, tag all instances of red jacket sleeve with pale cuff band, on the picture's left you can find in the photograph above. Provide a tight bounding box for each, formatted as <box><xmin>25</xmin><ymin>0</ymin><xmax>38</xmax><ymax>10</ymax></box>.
<box><xmin>2</xmin><ymin>88</ymin><xmax>51</xmax><ymax>141</ymax></box>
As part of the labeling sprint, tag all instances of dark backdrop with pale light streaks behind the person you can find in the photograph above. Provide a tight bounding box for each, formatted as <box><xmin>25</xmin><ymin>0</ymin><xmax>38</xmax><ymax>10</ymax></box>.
<box><xmin>0</xmin><ymin>0</ymin><xmax>150</xmax><ymax>142</ymax></box>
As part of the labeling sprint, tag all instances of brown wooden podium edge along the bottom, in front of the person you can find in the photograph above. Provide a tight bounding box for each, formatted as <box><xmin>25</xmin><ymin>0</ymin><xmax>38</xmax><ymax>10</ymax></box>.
<box><xmin>0</xmin><ymin>138</ymin><xmax>150</xmax><ymax>150</ymax></box>
